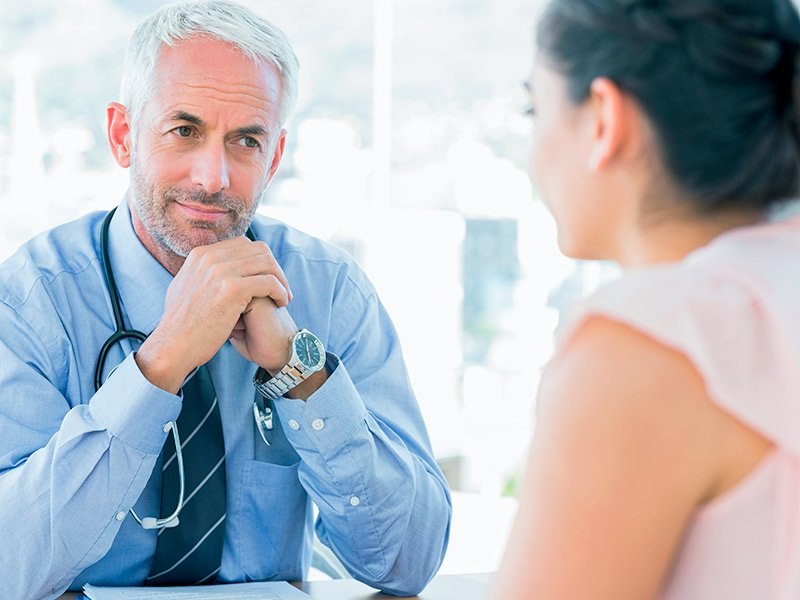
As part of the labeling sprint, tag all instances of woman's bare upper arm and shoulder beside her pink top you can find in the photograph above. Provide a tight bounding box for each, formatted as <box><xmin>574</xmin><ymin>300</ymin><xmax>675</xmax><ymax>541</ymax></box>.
<box><xmin>492</xmin><ymin>317</ymin><xmax>769</xmax><ymax>600</ymax></box>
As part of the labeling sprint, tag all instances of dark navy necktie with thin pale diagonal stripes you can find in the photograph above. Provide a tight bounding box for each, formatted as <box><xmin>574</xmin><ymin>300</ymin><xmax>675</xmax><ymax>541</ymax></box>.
<box><xmin>145</xmin><ymin>365</ymin><xmax>225</xmax><ymax>585</ymax></box>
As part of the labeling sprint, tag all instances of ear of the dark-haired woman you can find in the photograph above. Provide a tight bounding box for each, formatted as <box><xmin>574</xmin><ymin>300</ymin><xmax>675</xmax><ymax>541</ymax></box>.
<box><xmin>587</xmin><ymin>77</ymin><xmax>632</xmax><ymax>172</ymax></box>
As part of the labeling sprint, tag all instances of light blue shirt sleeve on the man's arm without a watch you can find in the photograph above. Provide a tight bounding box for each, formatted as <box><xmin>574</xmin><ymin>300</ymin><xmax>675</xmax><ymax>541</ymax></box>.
<box><xmin>0</xmin><ymin>303</ymin><xmax>180</xmax><ymax>598</ymax></box>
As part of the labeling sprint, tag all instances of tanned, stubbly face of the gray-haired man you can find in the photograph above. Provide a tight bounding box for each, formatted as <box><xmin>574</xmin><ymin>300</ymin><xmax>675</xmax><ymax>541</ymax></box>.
<box><xmin>129</xmin><ymin>37</ymin><xmax>285</xmax><ymax>258</ymax></box>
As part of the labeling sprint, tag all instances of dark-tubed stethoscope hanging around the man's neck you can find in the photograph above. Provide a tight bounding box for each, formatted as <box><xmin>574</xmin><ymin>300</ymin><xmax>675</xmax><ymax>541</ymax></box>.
<box><xmin>94</xmin><ymin>208</ymin><xmax>273</xmax><ymax>529</ymax></box>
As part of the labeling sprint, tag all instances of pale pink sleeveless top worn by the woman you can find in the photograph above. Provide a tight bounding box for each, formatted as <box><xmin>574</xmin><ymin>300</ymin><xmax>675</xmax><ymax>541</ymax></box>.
<box><xmin>561</xmin><ymin>217</ymin><xmax>800</xmax><ymax>600</ymax></box>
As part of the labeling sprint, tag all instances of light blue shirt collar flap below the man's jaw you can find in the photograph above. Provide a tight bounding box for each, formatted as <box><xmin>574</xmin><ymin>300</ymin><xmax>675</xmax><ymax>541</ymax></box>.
<box><xmin>108</xmin><ymin>194</ymin><xmax>173</xmax><ymax>335</ymax></box>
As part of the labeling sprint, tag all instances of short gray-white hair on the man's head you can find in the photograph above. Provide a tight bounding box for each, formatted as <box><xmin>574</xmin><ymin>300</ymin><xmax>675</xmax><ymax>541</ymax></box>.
<box><xmin>120</xmin><ymin>0</ymin><xmax>299</xmax><ymax>125</ymax></box>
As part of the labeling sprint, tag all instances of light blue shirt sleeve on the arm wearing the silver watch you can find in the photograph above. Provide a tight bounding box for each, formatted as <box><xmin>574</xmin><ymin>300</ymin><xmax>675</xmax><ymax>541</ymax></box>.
<box><xmin>276</xmin><ymin>284</ymin><xmax>452</xmax><ymax>596</ymax></box>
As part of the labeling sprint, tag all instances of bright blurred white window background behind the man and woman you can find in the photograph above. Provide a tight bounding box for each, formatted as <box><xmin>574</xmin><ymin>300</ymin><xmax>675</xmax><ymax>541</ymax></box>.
<box><xmin>0</xmin><ymin>0</ymin><xmax>614</xmax><ymax>572</ymax></box>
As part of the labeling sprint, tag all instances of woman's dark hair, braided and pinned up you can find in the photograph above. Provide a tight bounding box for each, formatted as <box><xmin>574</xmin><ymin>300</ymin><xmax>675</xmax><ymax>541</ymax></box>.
<box><xmin>537</xmin><ymin>0</ymin><xmax>800</xmax><ymax>213</ymax></box>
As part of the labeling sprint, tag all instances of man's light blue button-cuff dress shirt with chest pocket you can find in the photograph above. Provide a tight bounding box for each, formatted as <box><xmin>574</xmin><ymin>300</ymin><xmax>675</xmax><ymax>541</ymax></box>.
<box><xmin>0</xmin><ymin>202</ymin><xmax>451</xmax><ymax>599</ymax></box>
